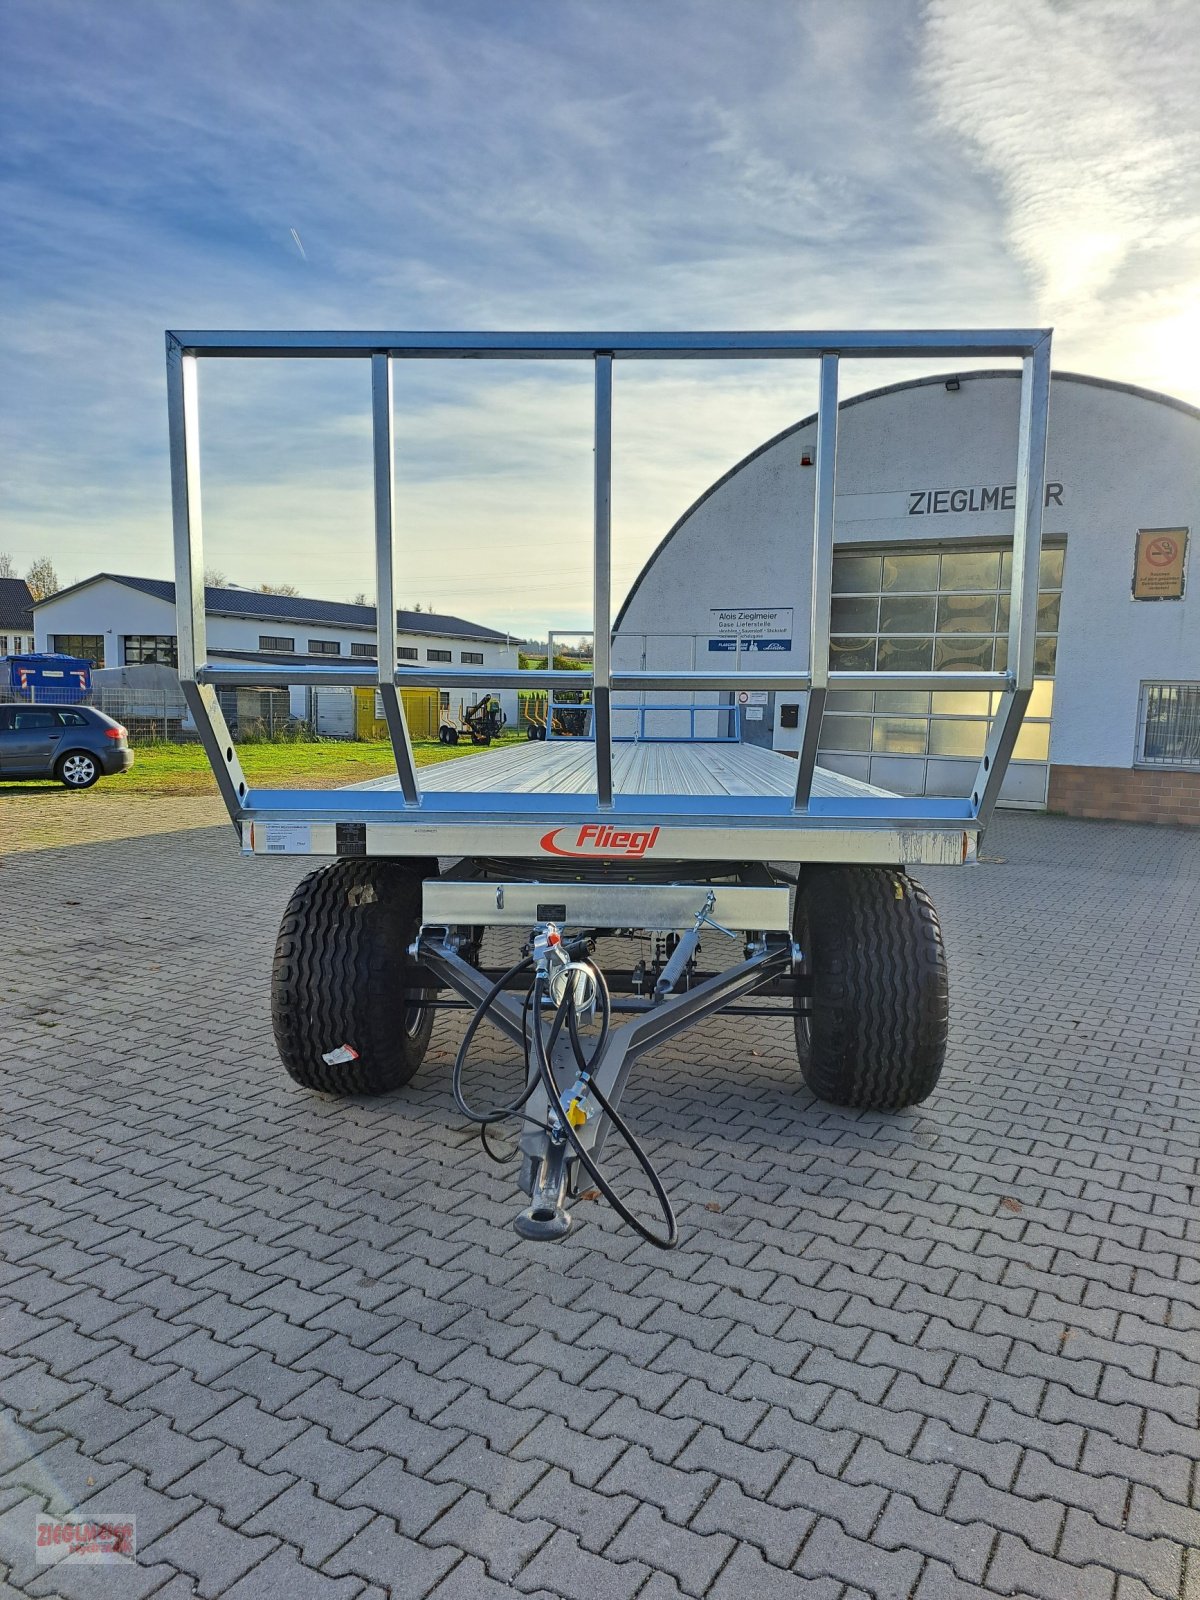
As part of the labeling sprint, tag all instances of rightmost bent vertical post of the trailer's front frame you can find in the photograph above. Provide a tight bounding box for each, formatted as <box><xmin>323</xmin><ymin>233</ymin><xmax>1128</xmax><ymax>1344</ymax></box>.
<box><xmin>971</xmin><ymin>329</ymin><xmax>1050</xmax><ymax>826</ymax></box>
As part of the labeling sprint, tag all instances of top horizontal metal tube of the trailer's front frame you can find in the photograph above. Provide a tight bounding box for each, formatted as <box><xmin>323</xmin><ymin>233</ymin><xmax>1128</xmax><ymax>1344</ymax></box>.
<box><xmin>166</xmin><ymin>328</ymin><xmax>1050</xmax><ymax>362</ymax></box>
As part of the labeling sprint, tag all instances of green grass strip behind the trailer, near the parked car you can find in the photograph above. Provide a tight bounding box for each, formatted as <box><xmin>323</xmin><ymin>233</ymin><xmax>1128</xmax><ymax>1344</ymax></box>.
<box><xmin>115</xmin><ymin>734</ymin><xmax>523</xmax><ymax>795</ymax></box>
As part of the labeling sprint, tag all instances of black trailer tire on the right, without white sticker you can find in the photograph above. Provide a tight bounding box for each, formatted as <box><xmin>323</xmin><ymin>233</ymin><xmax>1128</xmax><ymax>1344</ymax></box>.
<box><xmin>792</xmin><ymin>867</ymin><xmax>949</xmax><ymax>1110</ymax></box>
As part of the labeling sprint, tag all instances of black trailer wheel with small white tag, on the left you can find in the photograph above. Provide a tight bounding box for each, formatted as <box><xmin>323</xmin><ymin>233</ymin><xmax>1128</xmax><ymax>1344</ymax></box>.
<box><xmin>270</xmin><ymin>859</ymin><xmax>437</xmax><ymax>1094</ymax></box>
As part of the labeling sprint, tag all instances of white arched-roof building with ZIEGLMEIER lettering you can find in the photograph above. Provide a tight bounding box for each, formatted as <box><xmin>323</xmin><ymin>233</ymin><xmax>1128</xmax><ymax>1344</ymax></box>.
<box><xmin>614</xmin><ymin>371</ymin><xmax>1200</xmax><ymax>822</ymax></box>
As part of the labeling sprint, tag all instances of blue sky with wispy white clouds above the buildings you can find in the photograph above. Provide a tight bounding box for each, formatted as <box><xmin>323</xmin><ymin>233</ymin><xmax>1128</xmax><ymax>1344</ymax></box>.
<box><xmin>0</xmin><ymin>0</ymin><xmax>1200</xmax><ymax>637</ymax></box>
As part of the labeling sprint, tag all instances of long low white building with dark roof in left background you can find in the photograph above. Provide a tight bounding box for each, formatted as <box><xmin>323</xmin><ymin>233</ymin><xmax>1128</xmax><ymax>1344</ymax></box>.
<box><xmin>34</xmin><ymin>573</ymin><xmax>518</xmax><ymax>733</ymax></box>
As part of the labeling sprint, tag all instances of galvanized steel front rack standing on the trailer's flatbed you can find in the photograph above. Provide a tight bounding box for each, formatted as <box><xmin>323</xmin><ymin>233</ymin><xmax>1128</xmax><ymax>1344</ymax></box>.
<box><xmin>166</xmin><ymin>328</ymin><xmax>1050</xmax><ymax>854</ymax></box>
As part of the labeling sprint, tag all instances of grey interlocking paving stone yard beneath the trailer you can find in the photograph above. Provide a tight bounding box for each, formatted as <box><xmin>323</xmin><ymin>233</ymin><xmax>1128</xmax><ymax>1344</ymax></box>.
<box><xmin>0</xmin><ymin>814</ymin><xmax>1200</xmax><ymax>1600</ymax></box>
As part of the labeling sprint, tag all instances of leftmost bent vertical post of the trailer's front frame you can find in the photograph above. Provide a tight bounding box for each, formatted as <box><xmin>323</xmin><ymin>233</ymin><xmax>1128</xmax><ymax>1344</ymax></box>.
<box><xmin>166</xmin><ymin>333</ymin><xmax>246</xmax><ymax>826</ymax></box>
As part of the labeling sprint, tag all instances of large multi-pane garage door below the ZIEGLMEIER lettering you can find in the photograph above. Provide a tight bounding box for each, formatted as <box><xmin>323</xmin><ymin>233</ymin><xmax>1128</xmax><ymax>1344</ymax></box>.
<box><xmin>819</xmin><ymin>544</ymin><xmax>1064</xmax><ymax>805</ymax></box>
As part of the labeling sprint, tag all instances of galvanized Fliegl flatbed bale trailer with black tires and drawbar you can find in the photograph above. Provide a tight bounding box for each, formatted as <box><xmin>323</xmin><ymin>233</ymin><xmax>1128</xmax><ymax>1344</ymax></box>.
<box><xmin>166</xmin><ymin>330</ymin><xmax>1050</xmax><ymax>1248</ymax></box>
